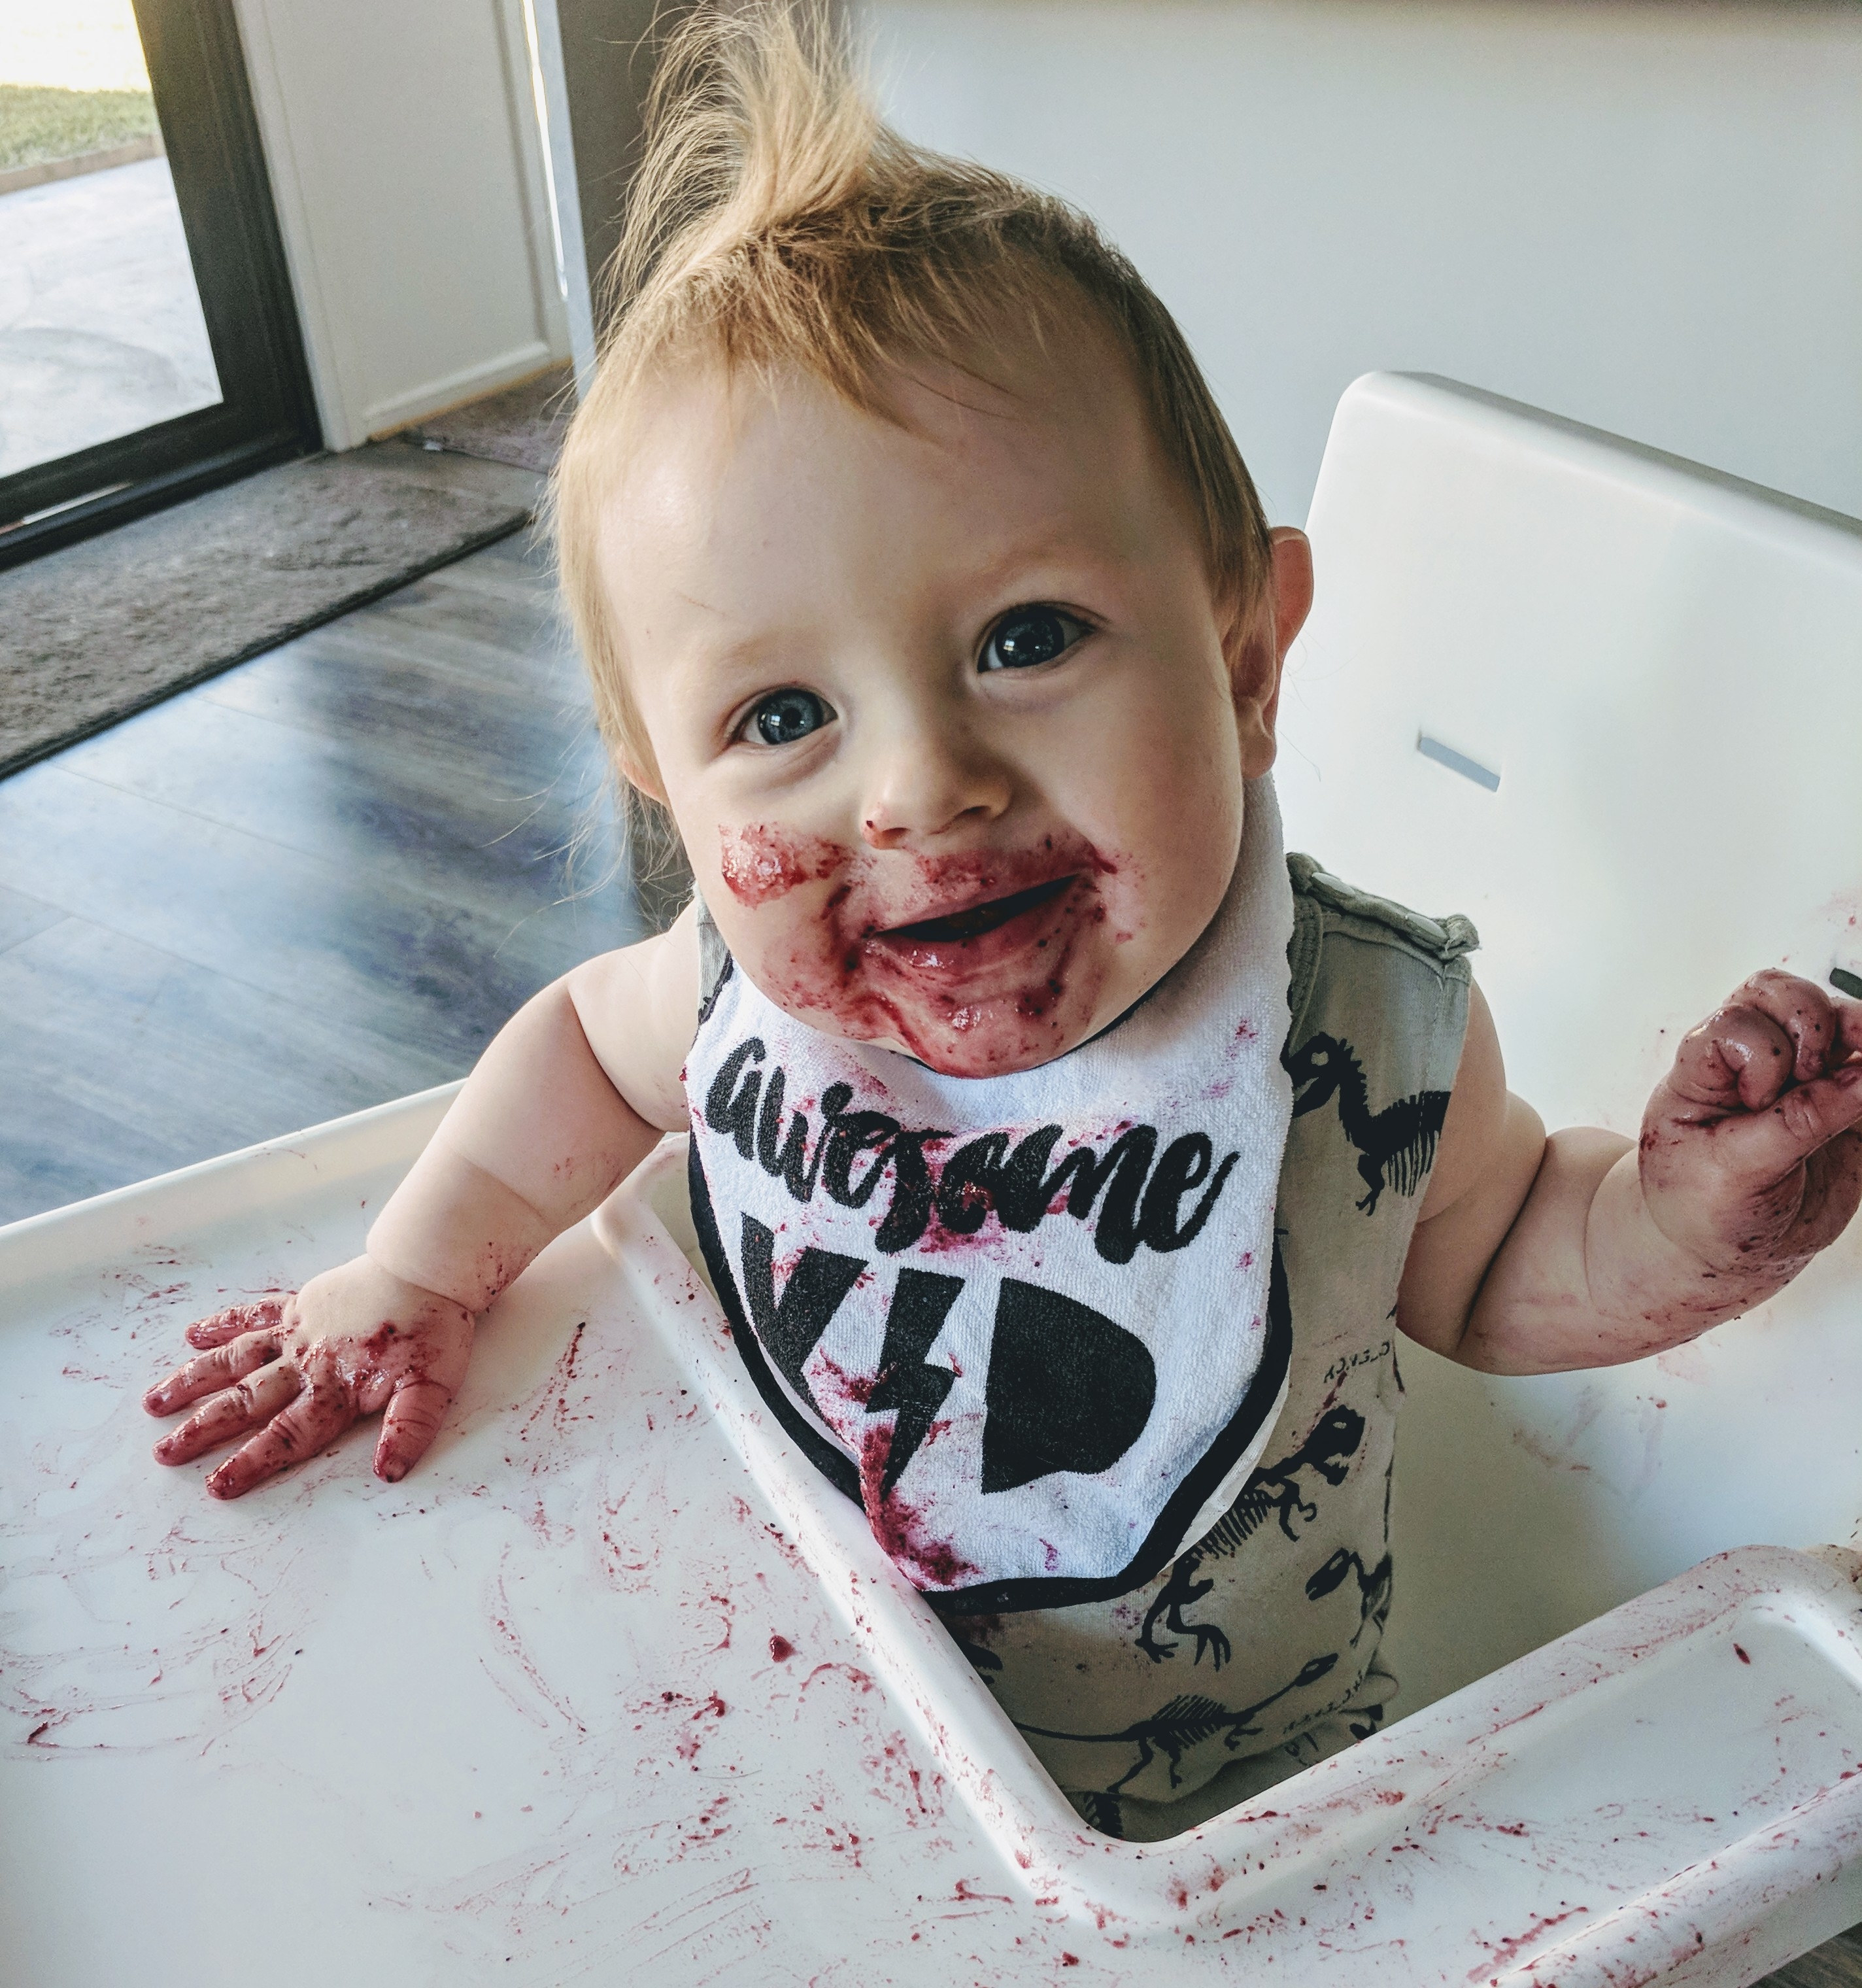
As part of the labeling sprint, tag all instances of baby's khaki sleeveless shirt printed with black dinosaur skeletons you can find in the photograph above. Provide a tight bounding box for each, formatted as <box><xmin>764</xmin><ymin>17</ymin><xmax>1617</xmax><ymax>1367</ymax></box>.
<box><xmin>688</xmin><ymin>855</ymin><xmax>1478</xmax><ymax>1839</ymax></box>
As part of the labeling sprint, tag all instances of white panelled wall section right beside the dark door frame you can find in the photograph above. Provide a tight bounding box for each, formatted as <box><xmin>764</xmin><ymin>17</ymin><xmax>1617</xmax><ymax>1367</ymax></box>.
<box><xmin>239</xmin><ymin>0</ymin><xmax>568</xmax><ymax>449</ymax></box>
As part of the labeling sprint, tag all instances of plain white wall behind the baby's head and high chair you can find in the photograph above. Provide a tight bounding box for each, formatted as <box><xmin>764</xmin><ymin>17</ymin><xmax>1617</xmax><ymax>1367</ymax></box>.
<box><xmin>860</xmin><ymin>0</ymin><xmax>1862</xmax><ymax>521</ymax></box>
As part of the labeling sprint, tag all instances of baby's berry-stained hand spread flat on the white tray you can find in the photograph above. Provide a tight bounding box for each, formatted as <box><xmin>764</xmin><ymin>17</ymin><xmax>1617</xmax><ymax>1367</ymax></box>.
<box><xmin>143</xmin><ymin>1256</ymin><xmax>473</xmax><ymax>1497</ymax></box>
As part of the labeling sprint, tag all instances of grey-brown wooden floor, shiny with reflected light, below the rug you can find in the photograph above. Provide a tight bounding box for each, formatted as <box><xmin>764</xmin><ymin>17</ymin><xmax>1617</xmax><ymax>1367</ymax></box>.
<box><xmin>0</xmin><ymin>451</ymin><xmax>1862</xmax><ymax>1988</ymax></box>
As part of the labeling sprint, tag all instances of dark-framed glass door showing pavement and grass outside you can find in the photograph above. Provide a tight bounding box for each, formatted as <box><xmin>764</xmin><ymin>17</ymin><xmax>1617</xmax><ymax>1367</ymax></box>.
<box><xmin>0</xmin><ymin>0</ymin><xmax>318</xmax><ymax>564</ymax></box>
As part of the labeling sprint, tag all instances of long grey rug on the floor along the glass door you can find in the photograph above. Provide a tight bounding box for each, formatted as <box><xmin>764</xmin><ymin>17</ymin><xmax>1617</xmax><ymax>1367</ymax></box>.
<box><xmin>0</xmin><ymin>449</ymin><xmax>531</xmax><ymax>776</ymax></box>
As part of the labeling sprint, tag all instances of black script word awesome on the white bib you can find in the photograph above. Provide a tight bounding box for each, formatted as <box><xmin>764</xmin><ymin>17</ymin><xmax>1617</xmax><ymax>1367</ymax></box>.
<box><xmin>705</xmin><ymin>1036</ymin><xmax>1240</xmax><ymax>1262</ymax></box>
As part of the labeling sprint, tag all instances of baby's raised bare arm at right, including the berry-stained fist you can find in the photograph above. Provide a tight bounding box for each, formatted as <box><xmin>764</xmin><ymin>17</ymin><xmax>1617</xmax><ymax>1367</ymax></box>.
<box><xmin>1397</xmin><ymin>972</ymin><xmax>1862</xmax><ymax>1374</ymax></box>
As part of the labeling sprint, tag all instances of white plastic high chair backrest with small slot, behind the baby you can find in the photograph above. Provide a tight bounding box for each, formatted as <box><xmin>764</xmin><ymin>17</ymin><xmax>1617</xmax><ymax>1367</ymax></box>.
<box><xmin>1276</xmin><ymin>374</ymin><xmax>1862</xmax><ymax>1709</ymax></box>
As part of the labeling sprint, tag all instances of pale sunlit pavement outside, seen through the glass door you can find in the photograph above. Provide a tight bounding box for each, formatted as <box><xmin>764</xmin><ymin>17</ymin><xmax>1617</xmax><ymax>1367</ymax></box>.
<box><xmin>0</xmin><ymin>159</ymin><xmax>220</xmax><ymax>477</ymax></box>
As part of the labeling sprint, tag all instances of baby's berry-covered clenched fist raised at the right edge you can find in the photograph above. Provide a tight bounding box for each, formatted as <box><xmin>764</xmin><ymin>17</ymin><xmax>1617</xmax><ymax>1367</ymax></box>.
<box><xmin>1642</xmin><ymin>972</ymin><xmax>1862</xmax><ymax>1304</ymax></box>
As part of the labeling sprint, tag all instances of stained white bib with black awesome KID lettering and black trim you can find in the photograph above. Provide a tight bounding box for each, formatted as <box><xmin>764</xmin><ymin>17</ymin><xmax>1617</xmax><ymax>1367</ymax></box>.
<box><xmin>686</xmin><ymin>780</ymin><xmax>1292</xmax><ymax>1614</ymax></box>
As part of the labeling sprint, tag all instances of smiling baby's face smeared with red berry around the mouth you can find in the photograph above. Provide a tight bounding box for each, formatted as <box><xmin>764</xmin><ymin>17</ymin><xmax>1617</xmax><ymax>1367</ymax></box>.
<box><xmin>602</xmin><ymin>340</ymin><xmax>1278</xmax><ymax>1076</ymax></box>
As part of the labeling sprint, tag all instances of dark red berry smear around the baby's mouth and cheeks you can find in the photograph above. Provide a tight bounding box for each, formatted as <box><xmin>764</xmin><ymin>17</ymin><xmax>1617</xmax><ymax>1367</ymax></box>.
<box><xmin>719</xmin><ymin>821</ymin><xmax>1126</xmax><ymax>1076</ymax></box>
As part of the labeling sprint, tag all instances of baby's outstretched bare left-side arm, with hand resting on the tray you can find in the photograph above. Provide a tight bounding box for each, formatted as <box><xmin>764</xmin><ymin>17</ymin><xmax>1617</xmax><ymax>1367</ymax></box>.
<box><xmin>145</xmin><ymin>912</ymin><xmax>698</xmax><ymax>1497</ymax></box>
